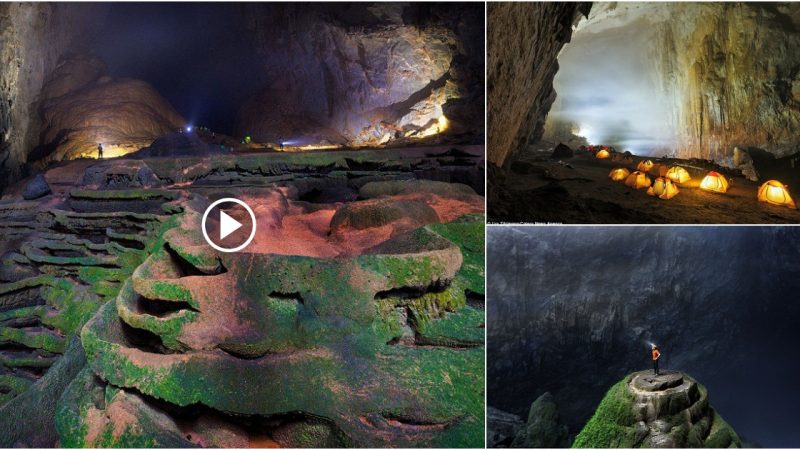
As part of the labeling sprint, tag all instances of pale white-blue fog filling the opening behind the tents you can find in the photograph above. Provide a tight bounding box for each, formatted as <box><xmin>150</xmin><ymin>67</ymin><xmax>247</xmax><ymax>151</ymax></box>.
<box><xmin>547</xmin><ymin>17</ymin><xmax>675</xmax><ymax>155</ymax></box>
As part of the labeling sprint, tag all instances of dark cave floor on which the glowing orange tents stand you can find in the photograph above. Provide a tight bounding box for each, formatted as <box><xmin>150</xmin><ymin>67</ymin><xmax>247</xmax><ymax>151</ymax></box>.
<box><xmin>487</xmin><ymin>149</ymin><xmax>800</xmax><ymax>224</ymax></box>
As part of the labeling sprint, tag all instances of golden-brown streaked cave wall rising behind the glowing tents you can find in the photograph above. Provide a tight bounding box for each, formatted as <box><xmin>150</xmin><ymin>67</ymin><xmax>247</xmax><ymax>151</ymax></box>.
<box><xmin>662</xmin><ymin>3</ymin><xmax>800</xmax><ymax>160</ymax></box>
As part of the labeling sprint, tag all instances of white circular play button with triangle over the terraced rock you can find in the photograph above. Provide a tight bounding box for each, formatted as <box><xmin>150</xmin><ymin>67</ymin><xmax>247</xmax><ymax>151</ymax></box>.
<box><xmin>201</xmin><ymin>198</ymin><xmax>256</xmax><ymax>253</ymax></box>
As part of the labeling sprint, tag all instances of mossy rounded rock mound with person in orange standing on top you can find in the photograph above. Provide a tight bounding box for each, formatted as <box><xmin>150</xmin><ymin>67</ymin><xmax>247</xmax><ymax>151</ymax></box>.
<box><xmin>574</xmin><ymin>371</ymin><xmax>742</xmax><ymax>448</ymax></box>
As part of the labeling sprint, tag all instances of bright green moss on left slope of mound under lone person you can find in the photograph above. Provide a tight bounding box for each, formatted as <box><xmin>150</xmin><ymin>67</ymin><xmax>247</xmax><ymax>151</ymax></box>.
<box><xmin>572</xmin><ymin>376</ymin><xmax>636</xmax><ymax>448</ymax></box>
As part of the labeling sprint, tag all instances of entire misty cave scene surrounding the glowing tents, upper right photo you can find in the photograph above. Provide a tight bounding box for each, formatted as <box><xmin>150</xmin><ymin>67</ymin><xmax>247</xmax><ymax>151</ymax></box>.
<box><xmin>488</xmin><ymin>2</ymin><xmax>800</xmax><ymax>223</ymax></box>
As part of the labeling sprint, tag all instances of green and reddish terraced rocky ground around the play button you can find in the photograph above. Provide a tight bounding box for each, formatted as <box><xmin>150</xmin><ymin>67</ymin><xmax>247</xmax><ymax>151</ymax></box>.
<box><xmin>0</xmin><ymin>147</ymin><xmax>484</xmax><ymax>447</ymax></box>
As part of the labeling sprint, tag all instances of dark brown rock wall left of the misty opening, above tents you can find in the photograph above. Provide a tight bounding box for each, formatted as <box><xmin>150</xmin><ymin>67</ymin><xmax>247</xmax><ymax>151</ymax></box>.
<box><xmin>487</xmin><ymin>2</ymin><xmax>591</xmax><ymax>167</ymax></box>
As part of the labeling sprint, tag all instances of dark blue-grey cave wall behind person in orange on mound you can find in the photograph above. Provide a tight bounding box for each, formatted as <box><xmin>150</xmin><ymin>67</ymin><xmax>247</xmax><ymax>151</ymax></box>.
<box><xmin>487</xmin><ymin>227</ymin><xmax>800</xmax><ymax>446</ymax></box>
